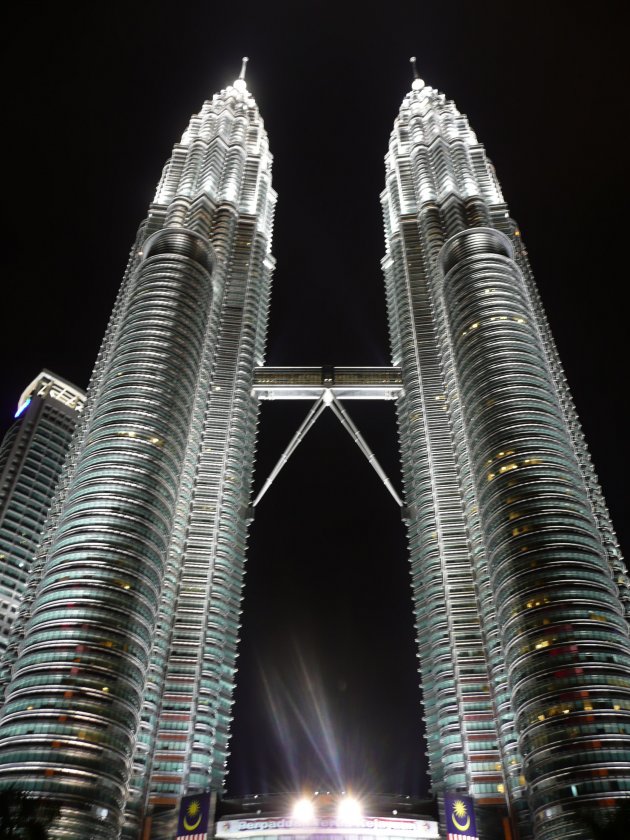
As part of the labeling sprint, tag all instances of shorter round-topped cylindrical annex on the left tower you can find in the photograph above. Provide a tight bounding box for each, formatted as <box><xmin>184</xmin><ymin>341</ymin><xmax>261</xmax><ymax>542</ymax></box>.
<box><xmin>0</xmin><ymin>228</ymin><xmax>212</xmax><ymax>839</ymax></box>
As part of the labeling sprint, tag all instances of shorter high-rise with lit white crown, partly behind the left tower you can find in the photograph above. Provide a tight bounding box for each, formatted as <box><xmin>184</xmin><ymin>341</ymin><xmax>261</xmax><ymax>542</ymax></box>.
<box><xmin>0</xmin><ymin>370</ymin><xmax>85</xmax><ymax>655</ymax></box>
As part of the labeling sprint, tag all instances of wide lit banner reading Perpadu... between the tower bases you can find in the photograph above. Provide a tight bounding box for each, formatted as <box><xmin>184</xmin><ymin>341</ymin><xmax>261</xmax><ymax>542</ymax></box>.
<box><xmin>216</xmin><ymin>817</ymin><xmax>439</xmax><ymax>840</ymax></box>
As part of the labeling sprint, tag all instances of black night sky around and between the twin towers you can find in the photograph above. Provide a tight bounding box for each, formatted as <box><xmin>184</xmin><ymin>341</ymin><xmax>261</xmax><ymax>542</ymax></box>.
<box><xmin>0</xmin><ymin>0</ymin><xmax>628</xmax><ymax>808</ymax></box>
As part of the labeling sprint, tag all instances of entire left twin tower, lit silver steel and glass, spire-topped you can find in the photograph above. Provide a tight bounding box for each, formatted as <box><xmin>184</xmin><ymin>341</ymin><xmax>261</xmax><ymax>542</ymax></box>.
<box><xmin>0</xmin><ymin>64</ymin><xmax>275</xmax><ymax>840</ymax></box>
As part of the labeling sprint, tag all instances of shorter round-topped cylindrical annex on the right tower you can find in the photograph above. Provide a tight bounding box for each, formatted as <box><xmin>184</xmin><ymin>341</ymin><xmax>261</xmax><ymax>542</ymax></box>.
<box><xmin>441</xmin><ymin>228</ymin><xmax>630</xmax><ymax>840</ymax></box>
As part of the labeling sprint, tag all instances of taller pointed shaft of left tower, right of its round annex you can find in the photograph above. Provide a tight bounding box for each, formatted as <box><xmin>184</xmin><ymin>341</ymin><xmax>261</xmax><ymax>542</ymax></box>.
<box><xmin>141</xmin><ymin>79</ymin><xmax>275</xmax><ymax>820</ymax></box>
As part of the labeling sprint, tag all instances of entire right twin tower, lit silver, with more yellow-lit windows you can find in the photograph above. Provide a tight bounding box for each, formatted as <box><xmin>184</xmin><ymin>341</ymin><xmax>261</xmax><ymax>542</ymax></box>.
<box><xmin>382</xmin><ymin>67</ymin><xmax>630</xmax><ymax>840</ymax></box>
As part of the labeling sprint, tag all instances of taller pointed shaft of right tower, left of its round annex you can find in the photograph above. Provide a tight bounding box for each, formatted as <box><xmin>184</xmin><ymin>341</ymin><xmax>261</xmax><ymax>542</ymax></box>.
<box><xmin>382</xmin><ymin>79</ymin><xmax>522</xmax><ymax>833</ymax></box>
